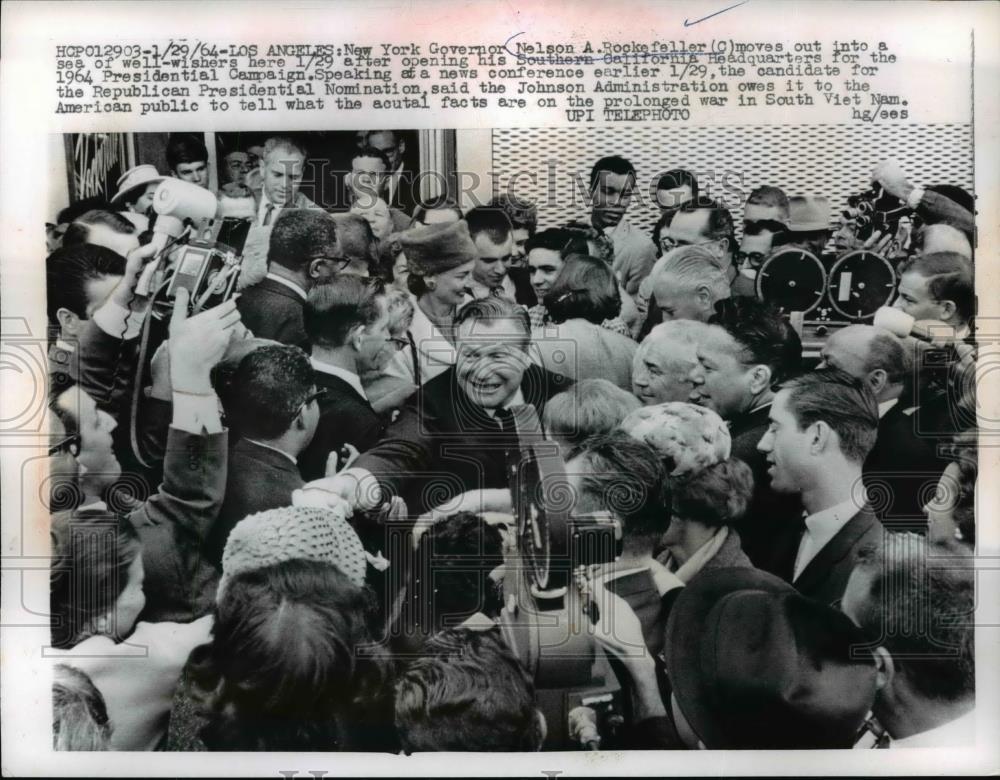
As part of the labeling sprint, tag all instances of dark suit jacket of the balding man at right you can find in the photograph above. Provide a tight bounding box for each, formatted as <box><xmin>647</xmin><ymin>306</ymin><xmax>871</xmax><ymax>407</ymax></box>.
<box><xmin>862</xmin><ymin>402</ymin><xmax>948</xmax><ymax>533</ymax></box>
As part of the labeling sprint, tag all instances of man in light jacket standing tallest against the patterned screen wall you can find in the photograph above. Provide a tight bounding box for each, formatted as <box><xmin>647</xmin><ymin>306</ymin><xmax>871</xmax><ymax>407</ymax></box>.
<box><xmin>590</xmin><ymin>155</ymin><xmax>656</xmax><ymax>295</ymax></box>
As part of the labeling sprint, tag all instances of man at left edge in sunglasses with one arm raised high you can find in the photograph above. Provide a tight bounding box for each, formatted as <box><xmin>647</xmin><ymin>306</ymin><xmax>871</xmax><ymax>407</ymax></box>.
<box><xmin>53</xmin><ymin>289</ymin><xmax>239</xmax><ymax>622</ymax></box>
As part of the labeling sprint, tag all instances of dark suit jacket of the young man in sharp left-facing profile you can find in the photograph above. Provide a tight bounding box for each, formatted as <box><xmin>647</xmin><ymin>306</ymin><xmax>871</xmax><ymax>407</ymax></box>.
<box><xmin>792</xmin><ymin>505</ymin><xmax>885</xmax><ymax>607</ymax></box>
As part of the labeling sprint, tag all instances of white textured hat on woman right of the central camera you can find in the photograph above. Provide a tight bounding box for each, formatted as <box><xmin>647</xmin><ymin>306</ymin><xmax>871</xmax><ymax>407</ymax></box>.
<box><xmin>621</xmin><ymin>401</ymin><xmax>732</xmax><ymax>477</ymax></box>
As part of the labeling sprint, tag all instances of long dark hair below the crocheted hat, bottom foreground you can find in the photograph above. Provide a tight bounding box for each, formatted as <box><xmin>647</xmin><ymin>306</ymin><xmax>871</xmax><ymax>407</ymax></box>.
<box><xmin>188</xmin><ymin>560</ymin><xmax>392</xmax><ymax>751</ymax></box>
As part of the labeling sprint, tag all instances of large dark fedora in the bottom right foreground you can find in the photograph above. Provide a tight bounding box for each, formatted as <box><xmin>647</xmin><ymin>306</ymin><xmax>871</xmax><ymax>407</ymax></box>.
<box><xmin>666</xmin><ymin>568</ymin><xmax>876</xmax><ymax>749</ymax></box>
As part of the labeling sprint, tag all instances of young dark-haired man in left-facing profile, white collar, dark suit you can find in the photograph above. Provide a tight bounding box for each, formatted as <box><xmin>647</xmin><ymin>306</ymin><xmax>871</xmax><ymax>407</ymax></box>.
<box><xmin>757</xmin><ymin>369</ymin><xmax>883</xmax><ymax>606</ymax></box>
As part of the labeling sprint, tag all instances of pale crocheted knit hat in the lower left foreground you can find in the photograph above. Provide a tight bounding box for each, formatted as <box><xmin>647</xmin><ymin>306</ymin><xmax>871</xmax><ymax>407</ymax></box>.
<box><xmin>218</xmin><ymin>506</ymin><xmax>368</xmax><ymax>597</ymax></box>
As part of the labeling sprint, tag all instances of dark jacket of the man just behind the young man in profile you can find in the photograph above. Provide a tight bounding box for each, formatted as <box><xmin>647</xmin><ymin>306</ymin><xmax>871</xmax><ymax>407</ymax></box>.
<box><xmin>729</xmin><ymin>404</ymin><xmax>804</xmax><ymax>582</ymax></box>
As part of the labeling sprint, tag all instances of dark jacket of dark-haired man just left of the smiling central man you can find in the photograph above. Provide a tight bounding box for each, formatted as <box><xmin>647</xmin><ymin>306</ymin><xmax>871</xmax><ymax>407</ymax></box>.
<box><xmin>299</xmin><ymin>371</ymin><xmax>386</xmax><ymax>481</ymax></box>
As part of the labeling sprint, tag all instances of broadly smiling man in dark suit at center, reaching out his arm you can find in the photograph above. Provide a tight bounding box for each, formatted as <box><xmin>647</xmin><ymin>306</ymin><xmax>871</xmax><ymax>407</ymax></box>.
<box><xmin>312</xmin><ymin>297</ymin><xmax>568</xmax><ymax>515</ymax></box>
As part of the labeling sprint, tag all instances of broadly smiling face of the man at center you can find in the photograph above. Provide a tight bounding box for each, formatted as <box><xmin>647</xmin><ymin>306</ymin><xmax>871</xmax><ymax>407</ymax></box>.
<box><xmin>455</xmin><ymin>318</ymin><xmax>530</xmax><ymax>409</ymax></box>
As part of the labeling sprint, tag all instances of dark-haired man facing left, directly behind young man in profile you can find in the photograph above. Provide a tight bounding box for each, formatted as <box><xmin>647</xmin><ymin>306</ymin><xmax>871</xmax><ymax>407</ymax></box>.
<box><xmin>688</xmin><ymin>297</ymin><xmax>802</xmax><ymax>579</ymax></box>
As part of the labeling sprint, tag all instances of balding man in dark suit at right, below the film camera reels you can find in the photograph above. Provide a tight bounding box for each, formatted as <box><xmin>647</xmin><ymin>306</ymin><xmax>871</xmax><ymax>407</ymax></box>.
<box><xmin>820</xmin><ymin>325</ymin><xmax>947</xmax><ymax>533</ymax></box>
